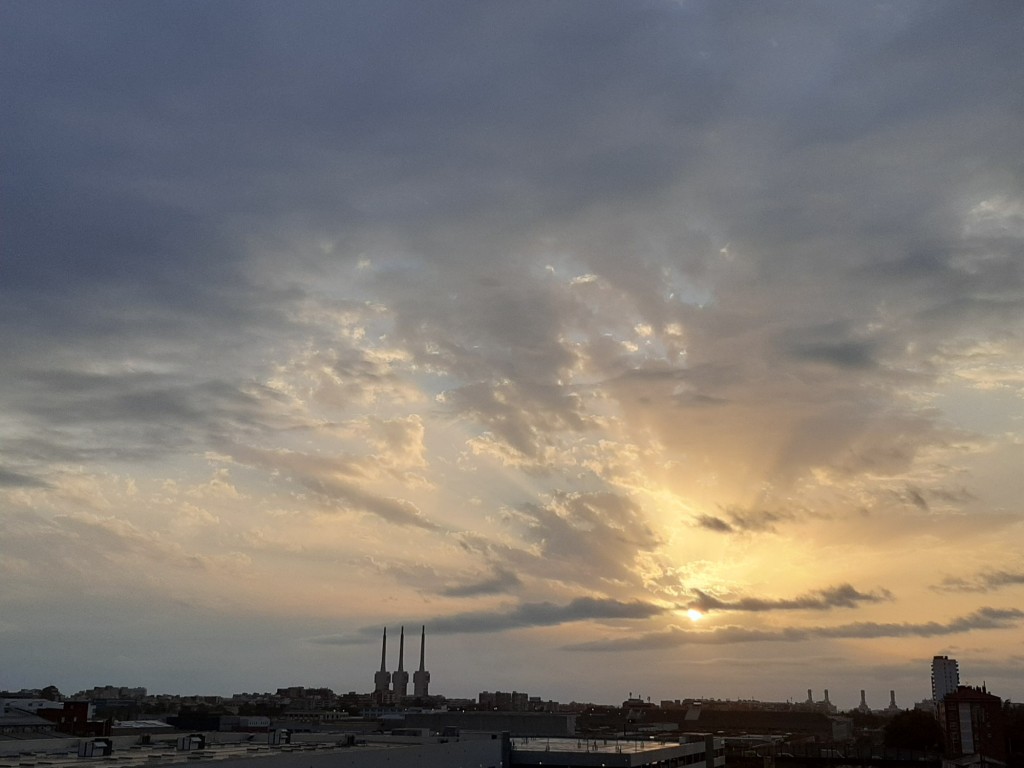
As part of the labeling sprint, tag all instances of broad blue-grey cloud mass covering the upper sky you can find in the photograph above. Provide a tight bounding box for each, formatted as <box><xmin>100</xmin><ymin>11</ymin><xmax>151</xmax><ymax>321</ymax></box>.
<box><xmin>0</xmin><ymin>3</ymin><xmax>1022</xmax><ymax>495</ymax></box>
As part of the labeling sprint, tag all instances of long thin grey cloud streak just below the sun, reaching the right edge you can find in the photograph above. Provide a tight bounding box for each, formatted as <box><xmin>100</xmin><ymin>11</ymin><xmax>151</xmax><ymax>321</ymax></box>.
<box><xmin>564</xmin><ymin>607</ymin><xmax>1024</xmax><ymax>651</ymax></box>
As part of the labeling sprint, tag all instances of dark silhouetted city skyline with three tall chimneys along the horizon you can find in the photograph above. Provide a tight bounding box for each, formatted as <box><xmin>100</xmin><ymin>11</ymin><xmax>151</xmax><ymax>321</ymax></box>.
<box><xmin>0</xmin><ymin>651</ymin><xmax>1024</xmax><ymax>768</ymax></box>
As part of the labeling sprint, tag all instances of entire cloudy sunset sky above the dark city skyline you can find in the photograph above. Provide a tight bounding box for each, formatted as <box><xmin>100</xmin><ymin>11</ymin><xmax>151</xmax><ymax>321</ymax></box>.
<box><xmin>0</xmin><ymin>0</ymin><xmax>1024</xmax><ymax>708</ymax></box>
